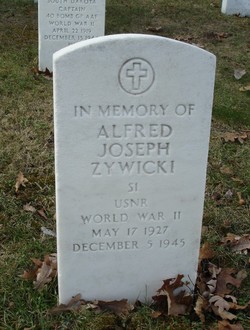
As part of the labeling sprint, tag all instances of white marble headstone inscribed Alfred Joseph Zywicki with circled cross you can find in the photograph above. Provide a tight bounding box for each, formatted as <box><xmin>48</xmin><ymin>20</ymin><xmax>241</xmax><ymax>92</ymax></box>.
<box><xmin>54</xmin><ymin>34</ymin><xmax>215</xmax><ymax>303</ymax></box>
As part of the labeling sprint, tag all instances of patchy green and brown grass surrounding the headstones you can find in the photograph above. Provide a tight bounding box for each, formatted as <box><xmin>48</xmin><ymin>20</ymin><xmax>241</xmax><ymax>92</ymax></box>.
<box><xmin>0</xmin><ymin>0</ymin><xmax>250</xmax><ymax>330</ymax></box>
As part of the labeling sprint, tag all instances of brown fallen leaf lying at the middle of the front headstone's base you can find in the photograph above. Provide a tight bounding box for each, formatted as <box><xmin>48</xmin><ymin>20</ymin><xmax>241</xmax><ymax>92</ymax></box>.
<box><xmin>95</xmin><ymin>299</ymin><xmax>134</xmax><ymax>315</ymax></box>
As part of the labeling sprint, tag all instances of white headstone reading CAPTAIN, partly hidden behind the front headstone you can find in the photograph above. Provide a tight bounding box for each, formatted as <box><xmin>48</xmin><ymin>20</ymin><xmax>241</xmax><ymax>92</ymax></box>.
<box><xmin>38</xmin><ymin>0</ymin><xmax>105</xmax><ymax>71</ymax></box>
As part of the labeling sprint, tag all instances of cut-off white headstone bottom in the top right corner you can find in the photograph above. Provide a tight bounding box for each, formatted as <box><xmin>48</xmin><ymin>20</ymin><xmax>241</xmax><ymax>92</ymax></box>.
<box><xmin>221</xmin><ymin>0</ymin><xmax>250</xmax><ymax>17</ymax></box>
